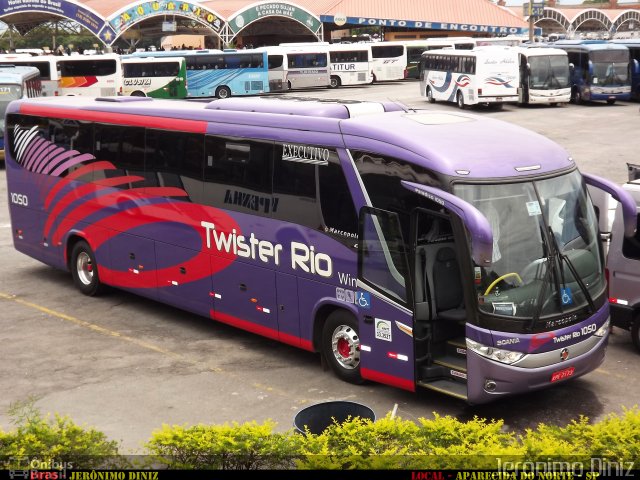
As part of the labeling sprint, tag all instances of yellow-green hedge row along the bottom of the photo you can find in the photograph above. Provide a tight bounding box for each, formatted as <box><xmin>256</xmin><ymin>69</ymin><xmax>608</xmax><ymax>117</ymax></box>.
<box><xmin>0</xmin><ymin>406</ymin><xmax>640</xmax><ymax>469</ymax></box>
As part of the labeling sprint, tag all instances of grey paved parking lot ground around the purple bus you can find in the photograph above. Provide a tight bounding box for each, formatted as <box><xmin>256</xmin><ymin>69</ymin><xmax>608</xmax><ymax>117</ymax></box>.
<box><xmin>0</xmin><ymin>82</ymin><xmax>640</xmax><ymax>453</ymax></box>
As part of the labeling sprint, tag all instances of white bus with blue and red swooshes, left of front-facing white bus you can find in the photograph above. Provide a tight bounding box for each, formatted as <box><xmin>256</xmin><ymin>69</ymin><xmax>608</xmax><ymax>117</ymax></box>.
<box><xmin>420</xmin><ymin>47</ymin><xmax>519</xmax><ymax>108</ymax></box>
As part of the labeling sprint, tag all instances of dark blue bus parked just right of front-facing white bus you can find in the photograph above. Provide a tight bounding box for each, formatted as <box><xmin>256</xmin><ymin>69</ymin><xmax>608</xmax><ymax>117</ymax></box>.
<box><xmin>552</xmin><ymin>40</ymin><xmax>631</xmax><ymax>105</ymax></box>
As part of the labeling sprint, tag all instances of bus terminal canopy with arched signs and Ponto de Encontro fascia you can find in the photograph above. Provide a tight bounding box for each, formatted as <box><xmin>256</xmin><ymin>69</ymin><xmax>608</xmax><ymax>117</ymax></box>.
<box><xmin>0</xmin><ymin>0</ymin><xmax>528</xmax><ymax>45</ymax></box>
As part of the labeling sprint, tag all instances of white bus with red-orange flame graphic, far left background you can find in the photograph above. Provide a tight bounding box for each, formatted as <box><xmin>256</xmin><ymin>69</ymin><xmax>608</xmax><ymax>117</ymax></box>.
<box><xmin>0</xmin><ymin>54</ymin><xmax>122</xmax><ymax>97</ymax></box>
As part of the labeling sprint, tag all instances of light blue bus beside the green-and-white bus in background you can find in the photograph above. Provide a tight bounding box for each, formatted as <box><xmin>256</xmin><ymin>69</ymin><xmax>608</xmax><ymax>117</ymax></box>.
<box><xmin>123</xmin><ymin>50</ymin><xmax>269</xmax><ymax>98</ymax></box>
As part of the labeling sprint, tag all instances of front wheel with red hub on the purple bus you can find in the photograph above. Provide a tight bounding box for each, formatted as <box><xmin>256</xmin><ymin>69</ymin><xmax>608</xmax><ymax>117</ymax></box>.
<box><xmin>322</xmin><ymin>310</ymin><xmax>364</xmax><ymax>384</ymax></box>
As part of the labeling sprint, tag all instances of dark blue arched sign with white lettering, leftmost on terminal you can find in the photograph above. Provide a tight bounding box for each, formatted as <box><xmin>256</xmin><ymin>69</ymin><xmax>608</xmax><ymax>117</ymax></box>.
<box><xmin>0</xmin><ymin>0</ymin><xmax>105</xmax><ymax>35</ymax></box>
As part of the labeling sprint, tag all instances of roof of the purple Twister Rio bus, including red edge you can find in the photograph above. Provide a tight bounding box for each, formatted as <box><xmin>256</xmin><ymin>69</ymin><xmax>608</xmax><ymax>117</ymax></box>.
<box><xmin>9</xmin><ymin>96</ymin><xmax>575</xmax><ymax>180</ymax></box>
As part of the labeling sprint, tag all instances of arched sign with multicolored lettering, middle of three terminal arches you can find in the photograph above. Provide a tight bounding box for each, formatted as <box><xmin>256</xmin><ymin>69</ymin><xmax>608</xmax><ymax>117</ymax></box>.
<box><xmin>109</xmin><ymin>0</ymin><xmax>223</xmax><ymax>35</ymax></box>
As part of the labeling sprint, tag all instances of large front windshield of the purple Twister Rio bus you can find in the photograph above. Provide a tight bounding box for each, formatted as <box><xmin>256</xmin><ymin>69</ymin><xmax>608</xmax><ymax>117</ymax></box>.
<box><xmin>455</xmin><ymin>172</ymin><xmax>605</xmax><ymax>326</ymax></box>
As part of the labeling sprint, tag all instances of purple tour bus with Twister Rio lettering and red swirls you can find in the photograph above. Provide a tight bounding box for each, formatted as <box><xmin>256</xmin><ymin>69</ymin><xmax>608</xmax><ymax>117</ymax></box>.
<box><xmin>6</xmin><ymin>97</ymin><xmax>636</xmax><ymax>404</ymax></box>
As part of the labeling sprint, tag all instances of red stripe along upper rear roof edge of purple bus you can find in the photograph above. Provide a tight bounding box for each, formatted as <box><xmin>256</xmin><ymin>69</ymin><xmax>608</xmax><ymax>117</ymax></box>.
<box><xmin>20</xmin><ymin>104</ymin><xmax>207</xmax><ymax>133</ymax></box>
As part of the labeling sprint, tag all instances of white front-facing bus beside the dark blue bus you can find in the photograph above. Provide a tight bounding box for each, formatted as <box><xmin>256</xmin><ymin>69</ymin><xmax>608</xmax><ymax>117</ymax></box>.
<box><xmin>518</xmin><ymin>46</ymin><xmax>571</xmax><ymax>105</ymax></box>
